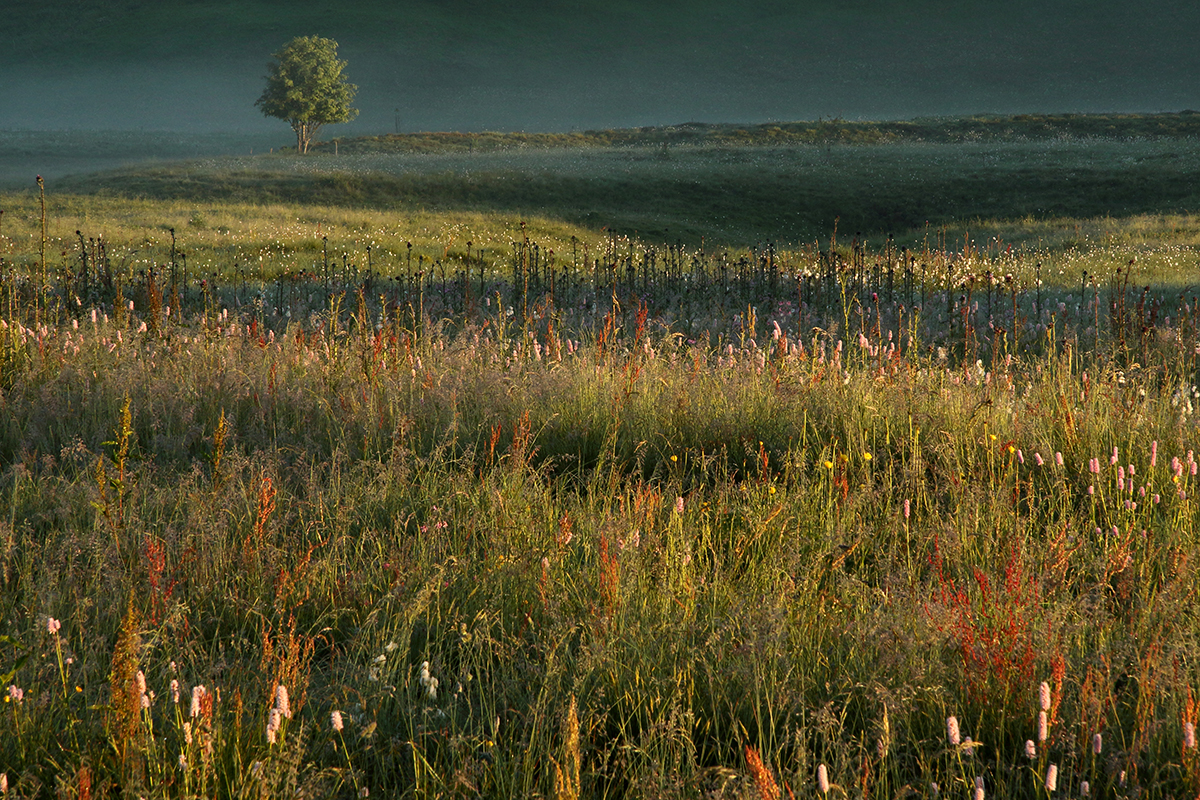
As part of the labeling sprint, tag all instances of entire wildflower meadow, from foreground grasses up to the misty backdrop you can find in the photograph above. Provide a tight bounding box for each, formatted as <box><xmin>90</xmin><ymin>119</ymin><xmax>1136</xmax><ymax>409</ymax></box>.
<box><xmin>0</xmin><ymin>122</ymin><xmax>1200</xmax><ymax>799</ymax></box>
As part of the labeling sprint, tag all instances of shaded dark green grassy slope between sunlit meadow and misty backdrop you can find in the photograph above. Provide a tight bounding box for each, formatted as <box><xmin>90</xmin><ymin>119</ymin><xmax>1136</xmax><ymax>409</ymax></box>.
<box><xmin>56</xmin><ymin>131</ymin><xmax>1200</xmax><ymax>246</ymax></box>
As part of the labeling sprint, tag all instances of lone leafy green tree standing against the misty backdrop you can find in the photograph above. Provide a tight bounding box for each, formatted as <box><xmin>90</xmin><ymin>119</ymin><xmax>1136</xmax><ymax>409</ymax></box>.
<box><xmin>254</xmin><ymin>36</ymin><xmax>359</xmax><ymax>154</ymax></box>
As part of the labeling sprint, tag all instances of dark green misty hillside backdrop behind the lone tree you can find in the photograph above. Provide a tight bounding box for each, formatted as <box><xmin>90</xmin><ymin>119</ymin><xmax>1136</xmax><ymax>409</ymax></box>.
<box><xmin>0</xmin><ymin>0</ymin><xmax>1200</xmax><ymax>140</ymax></box>
